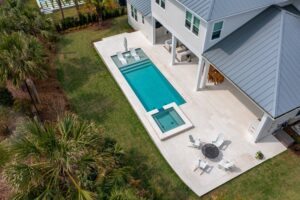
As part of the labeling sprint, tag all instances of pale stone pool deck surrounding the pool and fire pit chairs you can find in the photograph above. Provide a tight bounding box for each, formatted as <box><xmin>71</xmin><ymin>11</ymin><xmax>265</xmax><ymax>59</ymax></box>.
<box><xmin>94</xmin><ymin>32</ymin><xmax>286</xmax><ymax>196</ymax></box>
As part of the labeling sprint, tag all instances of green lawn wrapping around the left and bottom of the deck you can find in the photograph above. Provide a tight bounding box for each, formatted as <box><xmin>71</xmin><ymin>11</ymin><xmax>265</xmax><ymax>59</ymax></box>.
<box><xmin>57</xmin><ymin>16</ymin><xmax>300</xmax><ymax>200</ymax></box>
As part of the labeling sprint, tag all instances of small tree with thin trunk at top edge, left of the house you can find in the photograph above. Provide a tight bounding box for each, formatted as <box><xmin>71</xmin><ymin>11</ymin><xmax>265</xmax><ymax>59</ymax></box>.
<box><xmin>86</xmin><ymin>0</ymin><xmax>119</xmax><ymax>23</ymax></box>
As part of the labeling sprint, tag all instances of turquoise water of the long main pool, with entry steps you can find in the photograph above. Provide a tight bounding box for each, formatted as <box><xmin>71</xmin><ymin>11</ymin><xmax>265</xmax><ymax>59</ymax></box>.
<box><xmin>119</xmin><ymin>59</ymin><xmax>185</xmax><ymax>111</ymax></box>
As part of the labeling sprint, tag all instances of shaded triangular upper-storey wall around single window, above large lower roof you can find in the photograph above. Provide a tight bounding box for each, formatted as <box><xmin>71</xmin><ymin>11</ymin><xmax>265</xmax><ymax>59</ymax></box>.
<box><xmin>204</xmin><ymin>9</ymin><xmax>264</xmax><ymax>50</ymax></box>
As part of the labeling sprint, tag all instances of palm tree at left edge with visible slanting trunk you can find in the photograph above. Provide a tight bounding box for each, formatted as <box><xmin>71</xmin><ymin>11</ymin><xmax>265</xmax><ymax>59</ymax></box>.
<box><xmin>0</xmin><ymin>32</ymin><xmax>46</xmax><ymax>115</ymax></box>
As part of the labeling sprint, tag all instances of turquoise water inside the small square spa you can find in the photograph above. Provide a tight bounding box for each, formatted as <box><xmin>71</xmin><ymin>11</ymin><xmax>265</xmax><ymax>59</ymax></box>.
<box><xmin>152</xmin><ymin>108</ymin><xmax>184</xmax><ymax>133</ymax></box>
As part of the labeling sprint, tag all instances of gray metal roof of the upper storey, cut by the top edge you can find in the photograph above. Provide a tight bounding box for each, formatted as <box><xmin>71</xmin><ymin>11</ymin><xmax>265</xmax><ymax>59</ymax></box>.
<box><xmin>177</xmin><ymin>0</ymin><xmax>288</xmax><ymax>21</ymax></box>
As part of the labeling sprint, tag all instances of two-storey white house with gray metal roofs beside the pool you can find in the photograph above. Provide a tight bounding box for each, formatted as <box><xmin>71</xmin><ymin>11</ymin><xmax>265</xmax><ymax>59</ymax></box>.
<box><xmin>127</xmin><ymin>0</ymin><xmax>300</xmax><ymax>142</ymax></box>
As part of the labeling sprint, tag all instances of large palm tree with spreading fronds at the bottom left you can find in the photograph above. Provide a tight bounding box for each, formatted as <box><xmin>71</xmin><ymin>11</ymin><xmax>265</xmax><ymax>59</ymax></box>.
<box><xmin>4</xmin><ymin>114</ymin><xmax>125</xmax><ymax>200</ymax></box>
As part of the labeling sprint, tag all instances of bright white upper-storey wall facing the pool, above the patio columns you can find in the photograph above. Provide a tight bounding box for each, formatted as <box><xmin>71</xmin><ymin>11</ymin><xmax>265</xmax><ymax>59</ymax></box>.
<box><xmin>151</xmin><ymin>0</ymin><xmax>207</xmax><ymax>57</ymax></box>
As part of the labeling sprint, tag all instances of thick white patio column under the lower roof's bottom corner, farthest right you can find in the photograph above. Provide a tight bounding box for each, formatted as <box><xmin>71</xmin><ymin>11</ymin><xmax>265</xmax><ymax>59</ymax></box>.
<box><xmin>254</xmin><ymin>113</ymin><xmax>273</xmax><ymax>142</ymax></box>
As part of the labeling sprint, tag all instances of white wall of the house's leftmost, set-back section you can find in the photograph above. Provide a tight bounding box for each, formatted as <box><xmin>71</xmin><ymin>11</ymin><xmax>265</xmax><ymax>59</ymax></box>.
<box><xmin>127</xmin><ymin>3</ymin><xmax>154</xmax><ymax>44</ymax></box>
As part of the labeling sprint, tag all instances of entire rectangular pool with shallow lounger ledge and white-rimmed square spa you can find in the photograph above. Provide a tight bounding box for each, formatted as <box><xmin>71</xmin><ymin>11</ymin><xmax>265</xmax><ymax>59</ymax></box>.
<box><xmin>112</xmin><ymin>49</ymin><xmax>193</xmax><ymax>140</ymax></box>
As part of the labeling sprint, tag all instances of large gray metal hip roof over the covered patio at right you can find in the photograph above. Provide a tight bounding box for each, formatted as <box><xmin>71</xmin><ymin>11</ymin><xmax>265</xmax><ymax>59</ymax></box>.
<box><xmin>203</xmin><ymin>7</ymin><xmax>300</xmax><ymax>118</ymax></box>
